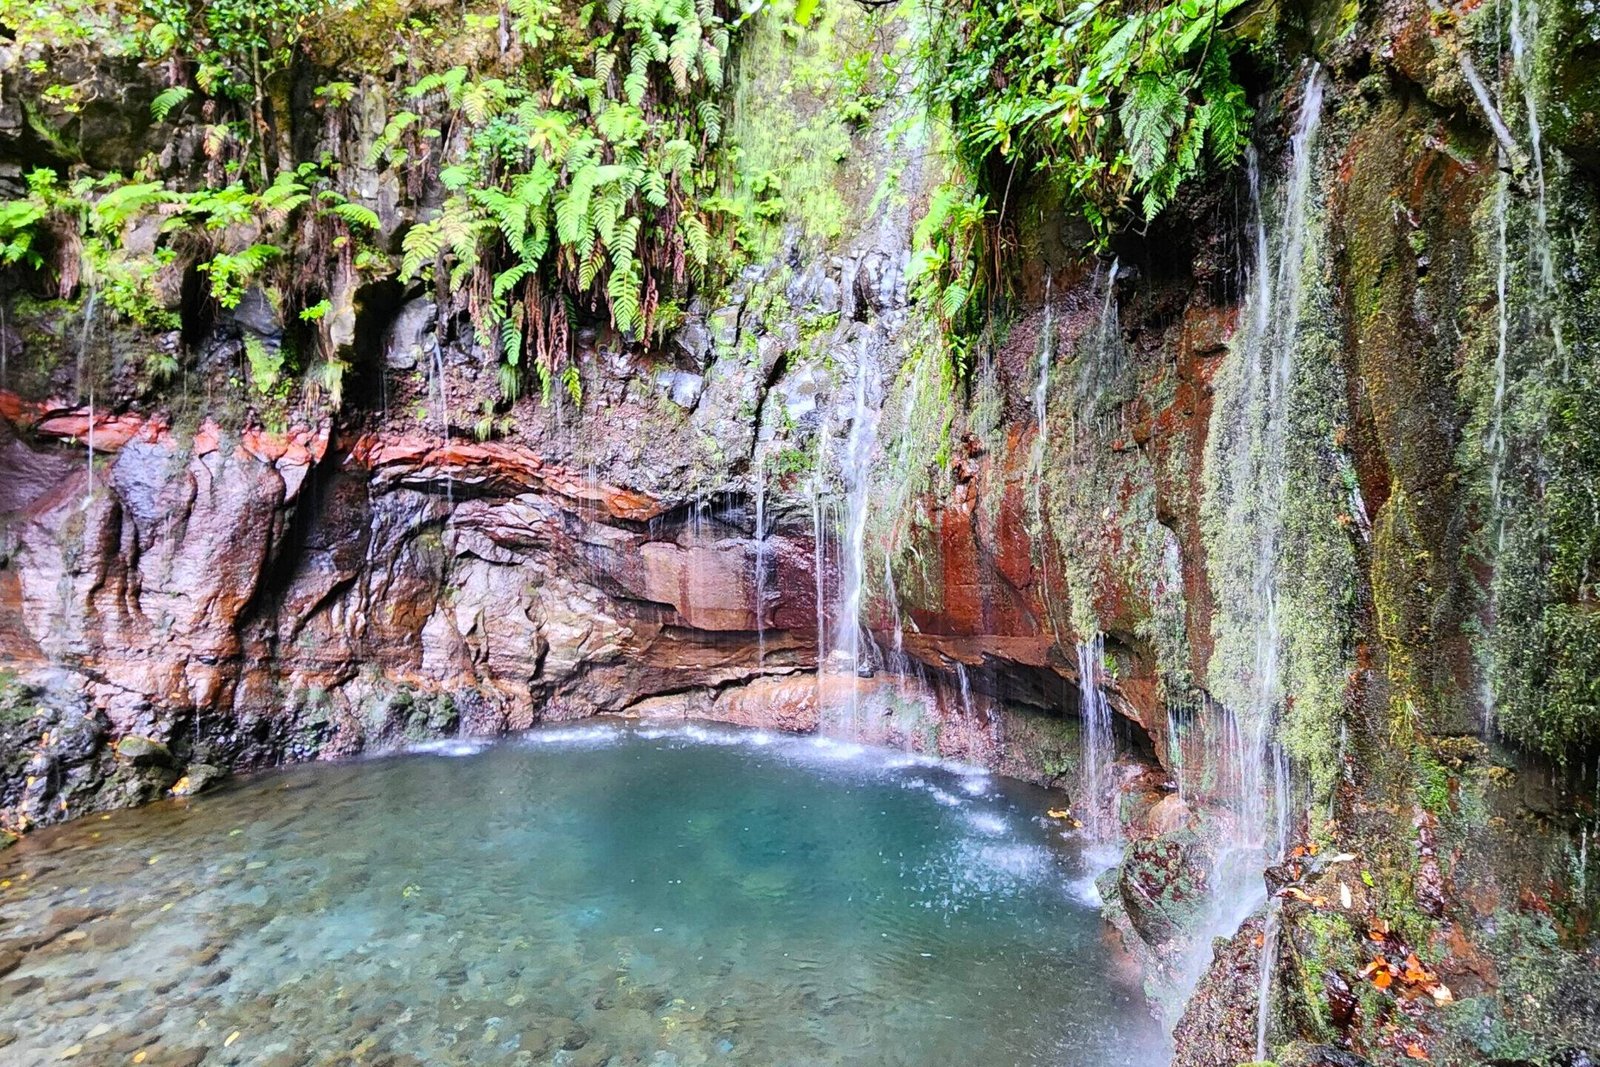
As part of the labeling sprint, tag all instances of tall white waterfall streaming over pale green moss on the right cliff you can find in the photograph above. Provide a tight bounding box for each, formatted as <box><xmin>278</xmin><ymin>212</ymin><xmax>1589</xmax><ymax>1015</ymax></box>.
<box><xmin>1184</xmin><ymin>66</ymin><xmax>1325</xmax><ymax>1059</ymax></box>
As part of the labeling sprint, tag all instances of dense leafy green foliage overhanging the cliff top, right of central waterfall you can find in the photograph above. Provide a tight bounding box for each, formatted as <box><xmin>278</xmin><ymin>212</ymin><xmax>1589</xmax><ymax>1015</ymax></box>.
<box><xmin>923</xmin><ymin>0</ymin><xmax>1250</xmax><ymax>245</ymax></box>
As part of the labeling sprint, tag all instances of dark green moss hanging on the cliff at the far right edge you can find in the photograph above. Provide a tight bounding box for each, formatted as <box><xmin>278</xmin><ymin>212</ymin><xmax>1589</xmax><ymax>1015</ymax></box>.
<box><xmin>1461</xmin><ymin>3</ymin><xmax>1600</xmax><ymax>761</ymax></box>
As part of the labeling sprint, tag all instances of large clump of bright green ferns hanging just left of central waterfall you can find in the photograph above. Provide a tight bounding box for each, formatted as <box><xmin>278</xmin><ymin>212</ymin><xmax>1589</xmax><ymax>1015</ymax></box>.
<box><xmin>392</xmin><ymin>0</ymin><xmax>755</xmax><ymax>400</ymax></box>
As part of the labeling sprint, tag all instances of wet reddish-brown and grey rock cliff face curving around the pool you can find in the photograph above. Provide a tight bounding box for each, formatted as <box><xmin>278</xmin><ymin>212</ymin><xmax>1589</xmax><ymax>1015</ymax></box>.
<box><xmin>0</xmin><ymin>3</ymin><xmax>1600</xmax><ymax>1064</ymax></box>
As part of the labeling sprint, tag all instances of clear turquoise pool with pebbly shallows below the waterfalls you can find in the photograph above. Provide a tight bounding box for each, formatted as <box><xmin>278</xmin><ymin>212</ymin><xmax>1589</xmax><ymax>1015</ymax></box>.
<box><xmin>0</xmin><ymin>725</ymin><xmax>1165</xmax><ymax>1067</ymax></box>
